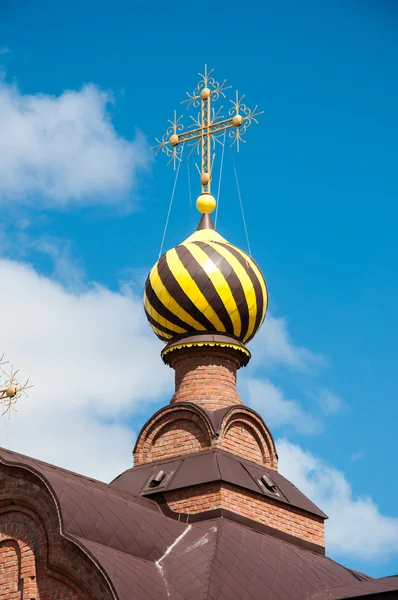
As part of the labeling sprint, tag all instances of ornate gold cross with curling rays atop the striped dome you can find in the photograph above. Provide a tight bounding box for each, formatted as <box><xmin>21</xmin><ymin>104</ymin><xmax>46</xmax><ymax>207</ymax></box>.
<box><xmin>153</xmin><ymin>65</ymin><xmax>262</xmax><ymax>193</ymax></box>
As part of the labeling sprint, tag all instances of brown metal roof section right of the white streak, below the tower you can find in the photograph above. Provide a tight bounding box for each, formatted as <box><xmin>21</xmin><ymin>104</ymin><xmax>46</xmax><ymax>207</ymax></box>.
<box><xmin>155</xmin><ymin>519</ymin><xmax>374</xmax><ymax>600</ymax></box>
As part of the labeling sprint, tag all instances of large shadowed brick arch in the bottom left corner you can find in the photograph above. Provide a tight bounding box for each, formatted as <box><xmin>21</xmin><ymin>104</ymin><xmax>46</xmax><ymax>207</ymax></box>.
<box><xmin>0</xmin><ymin>464</ymin><xmax>114</xmax><ymax>600</ymax></box>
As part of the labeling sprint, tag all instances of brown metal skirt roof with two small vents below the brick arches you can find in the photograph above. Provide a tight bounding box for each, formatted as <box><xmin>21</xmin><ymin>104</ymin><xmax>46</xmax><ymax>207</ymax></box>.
<box><xmin>111</xmin><ymin>449</ymin><xmax>327</xmax><ymax>519</ymax></box>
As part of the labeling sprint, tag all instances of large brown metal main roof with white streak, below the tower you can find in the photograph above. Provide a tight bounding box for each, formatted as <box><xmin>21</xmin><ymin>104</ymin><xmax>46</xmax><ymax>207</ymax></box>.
<box><xmin>0</xmin><ymin>450</ymin><xmax>397</xmax><ymax>600</ymax></box>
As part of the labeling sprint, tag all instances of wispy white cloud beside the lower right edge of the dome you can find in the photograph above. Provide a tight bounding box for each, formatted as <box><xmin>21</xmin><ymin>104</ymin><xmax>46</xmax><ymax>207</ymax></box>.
<box><xmin>250</xmin><ymin>313</ymin><xmax>325</xmax><ymax>372</ymax></box>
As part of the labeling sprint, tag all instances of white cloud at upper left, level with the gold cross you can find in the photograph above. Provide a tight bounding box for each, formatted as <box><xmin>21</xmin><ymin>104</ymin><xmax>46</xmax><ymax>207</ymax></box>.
<box><xmin>0</xmin><ymin>82</ymin><xmax>150</xmax><ymax>206</ymax></box>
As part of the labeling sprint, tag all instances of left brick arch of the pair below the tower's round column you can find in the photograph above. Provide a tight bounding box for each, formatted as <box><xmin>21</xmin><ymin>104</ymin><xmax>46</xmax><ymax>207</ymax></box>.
<box><xmin>134</xmin><ymin>406</ymin><xmax>212</xmax><ymax>465</ymax></box>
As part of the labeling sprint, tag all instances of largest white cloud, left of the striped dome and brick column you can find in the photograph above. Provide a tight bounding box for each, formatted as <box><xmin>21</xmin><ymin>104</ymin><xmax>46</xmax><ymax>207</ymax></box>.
<box><xmin>0</xmin><ymin>260</ymin><xmax>172</xmax><ymax>480</ymax></box>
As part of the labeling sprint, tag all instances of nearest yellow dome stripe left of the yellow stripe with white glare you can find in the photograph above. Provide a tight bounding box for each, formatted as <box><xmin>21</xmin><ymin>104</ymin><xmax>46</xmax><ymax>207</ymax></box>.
<box><xmin>166</xmin><ymin>248</ymin><xmax>226</xmax><ymax>331</ymax></box>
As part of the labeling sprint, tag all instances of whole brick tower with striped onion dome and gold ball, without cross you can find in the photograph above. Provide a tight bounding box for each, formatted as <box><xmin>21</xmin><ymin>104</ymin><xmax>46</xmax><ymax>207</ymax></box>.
<box><xmin>113</xmin><ymin>194</ymin><xmax>326</xmax><ymax>552</ymax></box>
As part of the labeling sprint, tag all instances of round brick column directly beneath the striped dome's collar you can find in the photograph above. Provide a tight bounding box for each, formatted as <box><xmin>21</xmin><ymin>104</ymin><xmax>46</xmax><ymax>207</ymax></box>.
<box><xmin>169</xmin><ymin>346</ymin><xmax>242</xmax><ymax>410</ymax></box>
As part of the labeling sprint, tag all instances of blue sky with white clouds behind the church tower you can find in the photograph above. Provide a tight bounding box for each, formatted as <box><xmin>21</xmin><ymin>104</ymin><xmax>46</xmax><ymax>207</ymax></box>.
<box><xmin>0</xmin><ymin>0</ymin><xmax>398</xmax><ymax>576</ymax></box>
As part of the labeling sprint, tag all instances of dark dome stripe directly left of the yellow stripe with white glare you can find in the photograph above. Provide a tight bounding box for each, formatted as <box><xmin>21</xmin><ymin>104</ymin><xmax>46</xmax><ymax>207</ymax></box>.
<box><xmin>176</xmin><ymin>246</ymin><xmax>234</xmax><ymax>335</ymax></box>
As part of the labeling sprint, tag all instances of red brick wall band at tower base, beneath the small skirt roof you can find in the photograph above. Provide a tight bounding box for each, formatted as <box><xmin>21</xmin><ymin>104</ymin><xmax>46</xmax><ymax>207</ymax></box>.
<box><xmin>166</xmin><ymin>483</ymin><xmax>325</xmax><ymax>546</ymax></box>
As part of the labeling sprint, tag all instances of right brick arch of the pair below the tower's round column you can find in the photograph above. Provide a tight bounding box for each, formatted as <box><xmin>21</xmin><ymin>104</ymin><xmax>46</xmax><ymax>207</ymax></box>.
<box><xmin>217</xmin><ymin>407</ymin><xmax>278</xmax><ymax>470</ymax></box>
